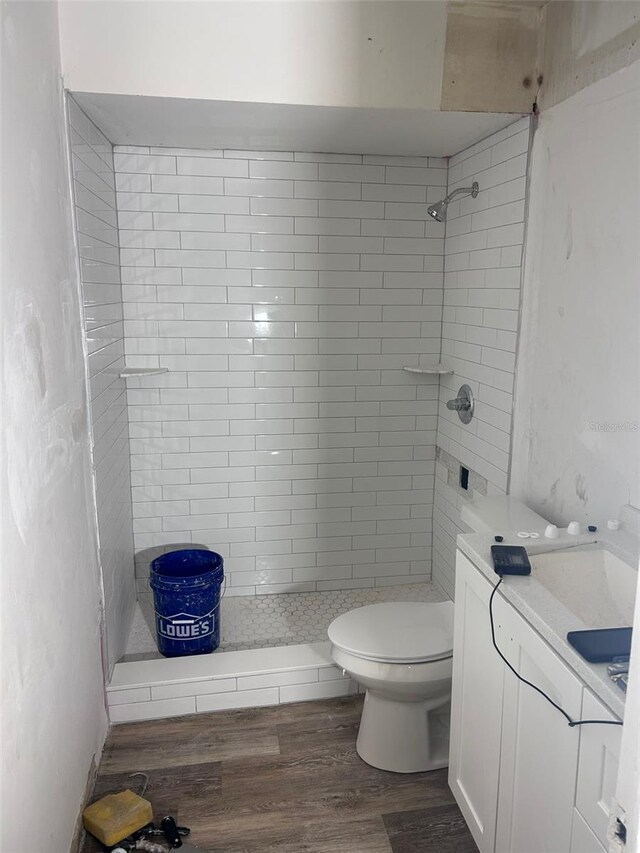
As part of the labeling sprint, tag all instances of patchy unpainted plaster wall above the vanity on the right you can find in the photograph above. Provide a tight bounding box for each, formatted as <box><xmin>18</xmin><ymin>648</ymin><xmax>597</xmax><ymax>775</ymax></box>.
<box><xmin>512</xmin><ymin>61</ymin><xmax>640</xmax><ymax>524</ymax></box>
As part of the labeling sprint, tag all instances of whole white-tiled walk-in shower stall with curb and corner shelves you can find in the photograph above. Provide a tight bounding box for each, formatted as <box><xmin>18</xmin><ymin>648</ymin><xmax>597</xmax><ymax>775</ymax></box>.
<box><xmin>68</xmin><ymin>91</ymin><xmax>529</xmax><ymax>721</ymax></box>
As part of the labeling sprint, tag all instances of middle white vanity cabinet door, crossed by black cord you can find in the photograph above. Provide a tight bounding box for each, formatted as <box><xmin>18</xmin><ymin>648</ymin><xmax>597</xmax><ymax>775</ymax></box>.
<box><xmin>494</xmin><ymin>596</ymin><xmax>582</xmax><ymax>853</ymax></box>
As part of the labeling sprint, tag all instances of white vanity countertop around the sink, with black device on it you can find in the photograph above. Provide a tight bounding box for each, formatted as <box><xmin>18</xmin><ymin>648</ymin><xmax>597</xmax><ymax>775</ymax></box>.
<box><xmin>458</xmin><ymin>530</ymin><xmax>639</xmax><ymax>719</ymax></box>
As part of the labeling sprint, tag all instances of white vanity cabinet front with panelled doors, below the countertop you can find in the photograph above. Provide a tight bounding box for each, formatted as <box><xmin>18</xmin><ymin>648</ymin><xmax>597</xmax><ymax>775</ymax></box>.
<box><xmin>449</xmin><ymin>551</ymin><xmax>621</xmax><ymax>853</ymax></box>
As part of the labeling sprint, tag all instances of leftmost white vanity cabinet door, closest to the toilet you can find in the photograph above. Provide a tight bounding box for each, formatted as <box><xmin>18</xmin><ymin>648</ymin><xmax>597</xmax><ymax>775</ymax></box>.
<box><xmin>449</xmin><ymin>551</ymin><xmax>504</xmax><ymax>853</ymax></box>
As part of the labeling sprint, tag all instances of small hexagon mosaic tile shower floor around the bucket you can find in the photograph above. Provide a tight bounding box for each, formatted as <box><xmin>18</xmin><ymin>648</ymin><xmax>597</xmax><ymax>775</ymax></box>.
<box><xmin>123</xmin><ymin>583</ymin><xmax>443</xmax><ymax>661</ymax></box>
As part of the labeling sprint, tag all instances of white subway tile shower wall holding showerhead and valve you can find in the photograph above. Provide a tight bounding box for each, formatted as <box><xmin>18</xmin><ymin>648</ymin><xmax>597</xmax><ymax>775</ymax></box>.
<box><xmin>433</xmin><ymin>118</ymin><xmax>530</xmax><ymax>596</ymax></box>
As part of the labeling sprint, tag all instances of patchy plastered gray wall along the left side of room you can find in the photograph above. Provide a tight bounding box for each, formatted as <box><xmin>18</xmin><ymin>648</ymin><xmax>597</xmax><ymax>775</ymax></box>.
<box><xmin>0</xmin><ymin>2</ymin><xmax>107</xmax><ymax>851</ymax></box>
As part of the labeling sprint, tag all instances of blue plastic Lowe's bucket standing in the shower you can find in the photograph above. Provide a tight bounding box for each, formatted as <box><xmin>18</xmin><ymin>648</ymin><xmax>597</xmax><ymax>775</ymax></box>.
<box><xmin>151</xmin><ymin>548</ymin><xmax>224</xmax><ymax>657</ymax></box>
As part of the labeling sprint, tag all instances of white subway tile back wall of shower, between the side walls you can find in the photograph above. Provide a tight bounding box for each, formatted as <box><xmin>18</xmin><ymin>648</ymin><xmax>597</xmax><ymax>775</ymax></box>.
<box><xmin>115</xmin><ymin>147</ymin><xmax>447</xmax><ymax>595</ymax></box>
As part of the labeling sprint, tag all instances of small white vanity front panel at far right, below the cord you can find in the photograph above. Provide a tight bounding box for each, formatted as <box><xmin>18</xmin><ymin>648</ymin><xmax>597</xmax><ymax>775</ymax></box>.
<box><xmin>576</xmin><ymin>689</ymin><xmax>622</xmax><ymax>846</ymax></box>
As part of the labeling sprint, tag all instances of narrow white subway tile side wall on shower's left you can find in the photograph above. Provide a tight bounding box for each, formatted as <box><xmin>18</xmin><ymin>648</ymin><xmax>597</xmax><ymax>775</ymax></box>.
<box><xmin>68</xmin><ymin>98</ymin><xmax>136</xmax><ymax>668</ymax></box>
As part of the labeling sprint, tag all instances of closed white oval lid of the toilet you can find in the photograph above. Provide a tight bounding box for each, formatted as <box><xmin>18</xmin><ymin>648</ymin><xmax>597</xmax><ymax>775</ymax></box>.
<box><xmin>329</xmin><ymin>601</ymin><xmax>453</xmax><ymax>663</ymax></box>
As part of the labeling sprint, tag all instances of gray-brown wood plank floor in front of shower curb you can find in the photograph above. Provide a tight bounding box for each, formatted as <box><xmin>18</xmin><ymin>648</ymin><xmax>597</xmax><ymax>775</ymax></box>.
<box><xmin>81</xmin><ymin>697</ymin><xmax>477</xmax><ymax>853</ymax></box>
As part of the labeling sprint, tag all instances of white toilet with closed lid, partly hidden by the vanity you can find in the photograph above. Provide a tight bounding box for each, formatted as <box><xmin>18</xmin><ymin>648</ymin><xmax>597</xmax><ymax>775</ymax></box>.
<box><xmin>328</xmin><ymin>496</ymin><xmax>546</xmax><ymax>773</ymax></box>
